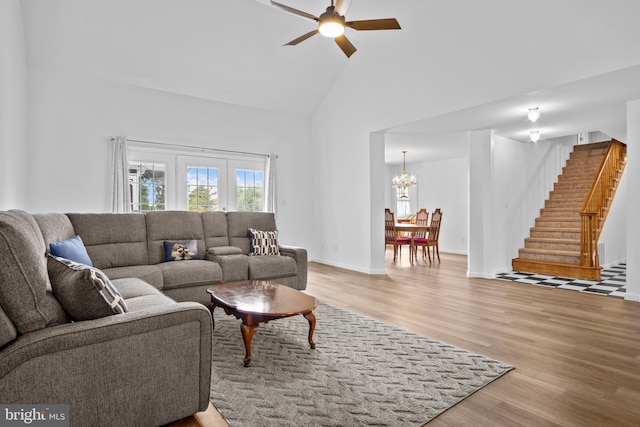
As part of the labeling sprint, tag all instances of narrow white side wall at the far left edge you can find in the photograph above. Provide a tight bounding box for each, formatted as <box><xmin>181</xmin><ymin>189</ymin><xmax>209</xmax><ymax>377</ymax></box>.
<box><xmin>0</xmin><ymin>0</ymin><xmax>29</xmax><ymax>210</ymax></box>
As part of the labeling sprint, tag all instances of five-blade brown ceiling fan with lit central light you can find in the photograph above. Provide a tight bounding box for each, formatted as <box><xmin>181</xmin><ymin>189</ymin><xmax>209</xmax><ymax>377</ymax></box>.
<box><xmin>271</xmin><ymin>0</ymin><xmax>400</xmax><ymax>58</ymax></box>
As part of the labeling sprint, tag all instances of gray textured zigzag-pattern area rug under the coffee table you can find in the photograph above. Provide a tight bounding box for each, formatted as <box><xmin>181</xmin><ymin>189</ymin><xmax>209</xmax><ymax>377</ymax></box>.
<box><xmin>211</xmin><ymin>302</ymin><xmax>513</xmax><ymax>427</ymax></box>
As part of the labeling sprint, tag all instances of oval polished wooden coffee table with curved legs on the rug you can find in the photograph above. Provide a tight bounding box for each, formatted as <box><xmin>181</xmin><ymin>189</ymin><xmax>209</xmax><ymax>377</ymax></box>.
<box><xmin>207</xmin><ymin>280</ymin><xmax>318</xmax><ymax>366</ymax></box>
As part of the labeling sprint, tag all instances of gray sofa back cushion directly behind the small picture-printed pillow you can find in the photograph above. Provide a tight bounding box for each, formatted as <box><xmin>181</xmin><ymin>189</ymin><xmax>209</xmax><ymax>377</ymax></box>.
<box><xmin>145</xmin><ymin>211</ymin><xmax>205</xmax><ymax>264</ymax></box>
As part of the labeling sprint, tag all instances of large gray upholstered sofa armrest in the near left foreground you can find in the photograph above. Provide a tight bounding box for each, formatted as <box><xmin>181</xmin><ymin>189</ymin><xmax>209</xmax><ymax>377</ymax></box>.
<box><xmin>0</xmin><ymin>302</ymin><xmax>212</xmax><ymax>426</ymax></box>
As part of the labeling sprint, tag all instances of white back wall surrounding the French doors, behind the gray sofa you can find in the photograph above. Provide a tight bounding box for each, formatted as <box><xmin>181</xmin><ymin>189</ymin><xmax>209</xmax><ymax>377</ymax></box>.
<box><xmin>27</xmin><ymin>69</ymin><xmax>313</xmax><ymax>251</ymax></box>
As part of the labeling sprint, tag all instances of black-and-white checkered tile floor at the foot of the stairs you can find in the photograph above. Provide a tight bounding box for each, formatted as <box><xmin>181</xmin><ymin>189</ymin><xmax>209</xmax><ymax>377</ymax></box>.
<box><xmin>496</xmin><ymin>263</ymin><xmax>627</xmax><ymax>298</ymax></box>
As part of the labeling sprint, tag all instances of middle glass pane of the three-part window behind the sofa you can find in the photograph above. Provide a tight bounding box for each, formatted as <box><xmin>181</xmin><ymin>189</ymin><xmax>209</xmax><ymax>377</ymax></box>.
<box><xmin>187</xmin><ymin>166</ymin><xmax>220</xmax><ymax>212</ymax></box>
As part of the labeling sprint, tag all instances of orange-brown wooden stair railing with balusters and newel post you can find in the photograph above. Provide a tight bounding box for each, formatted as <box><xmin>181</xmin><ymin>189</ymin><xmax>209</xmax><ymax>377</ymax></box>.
<box><xmin>580</xmin><ymin>139</ymin><xmax>627</xmax><ymax>268</ymax></box>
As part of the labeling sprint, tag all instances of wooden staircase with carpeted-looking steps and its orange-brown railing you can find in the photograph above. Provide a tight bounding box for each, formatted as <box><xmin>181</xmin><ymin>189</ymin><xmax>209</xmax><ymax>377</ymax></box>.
<box><xmin>512</xmin><ymin>140</ymin><xmax>626</xmax><ymax>280</ymax></box>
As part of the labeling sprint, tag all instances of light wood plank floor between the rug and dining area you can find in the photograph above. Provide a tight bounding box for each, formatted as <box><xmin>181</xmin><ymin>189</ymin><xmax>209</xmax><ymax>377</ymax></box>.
<box><xmin>169</xmin><ymin>250</ymin><xmax>640</xmax><ymax>427</ymax></box>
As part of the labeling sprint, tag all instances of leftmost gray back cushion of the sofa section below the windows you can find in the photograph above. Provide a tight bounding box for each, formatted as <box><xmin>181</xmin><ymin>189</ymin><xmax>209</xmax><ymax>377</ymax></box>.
<box><xmin>67</xmin><ymin>213</ymin><xmax>148</xmax><ymax>270</ymax></box>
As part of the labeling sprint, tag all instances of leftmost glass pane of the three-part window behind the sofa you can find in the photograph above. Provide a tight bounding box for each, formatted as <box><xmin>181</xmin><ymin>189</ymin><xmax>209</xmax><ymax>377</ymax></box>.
<box><xmin>129</xmin><ymin>162</ymin><xmax>167</xmax><ymax>212</ymax></box>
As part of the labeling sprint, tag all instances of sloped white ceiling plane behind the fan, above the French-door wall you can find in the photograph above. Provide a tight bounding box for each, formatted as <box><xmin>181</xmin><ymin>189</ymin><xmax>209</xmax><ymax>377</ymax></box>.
<box><xmin>23</xmin><ymin>0</ymin><xmax>419</xmax><ymax>115</ymax></box>
